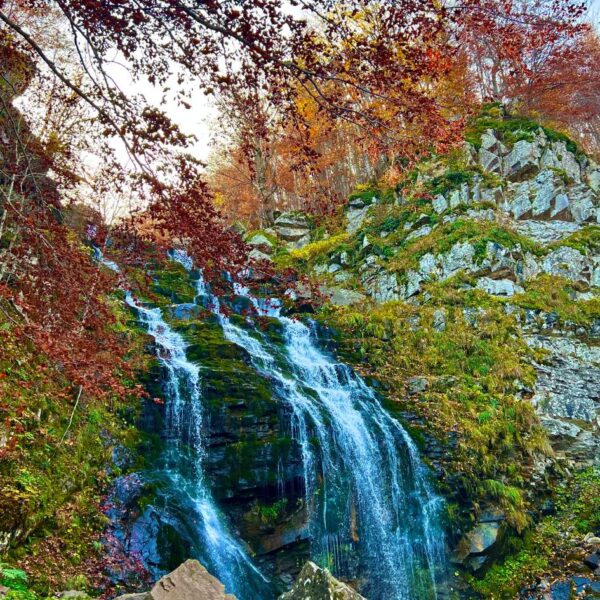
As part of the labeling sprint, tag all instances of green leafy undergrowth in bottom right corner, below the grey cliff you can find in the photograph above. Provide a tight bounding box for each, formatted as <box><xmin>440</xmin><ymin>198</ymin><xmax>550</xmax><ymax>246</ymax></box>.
<box><xmin>471</xmin><ymin>468</ymin><xmax>600</xmax><ymax>600</ymax></box>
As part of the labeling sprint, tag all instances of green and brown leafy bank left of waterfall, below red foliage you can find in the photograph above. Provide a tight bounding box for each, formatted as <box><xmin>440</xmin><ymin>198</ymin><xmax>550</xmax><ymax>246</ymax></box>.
<box><xmin>0</xmin><ymin>298</ymin><xmax>146</xmax><ymax>595</ymax></box>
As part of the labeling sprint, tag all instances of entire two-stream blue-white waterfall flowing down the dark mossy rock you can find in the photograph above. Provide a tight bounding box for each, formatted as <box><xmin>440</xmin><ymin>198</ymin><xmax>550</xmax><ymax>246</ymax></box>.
<box><xmin>117</xmin><ymin>246</ymin><xmax>445</xmax><ymax>600</ymax></box>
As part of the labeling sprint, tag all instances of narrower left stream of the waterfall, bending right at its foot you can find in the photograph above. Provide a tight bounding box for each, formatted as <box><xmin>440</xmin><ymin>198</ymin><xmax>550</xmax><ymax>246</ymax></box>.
<box><xmin>126</xmin><ymin>293</ymin><xmax>273</xmax><ymax>600</ymax></box>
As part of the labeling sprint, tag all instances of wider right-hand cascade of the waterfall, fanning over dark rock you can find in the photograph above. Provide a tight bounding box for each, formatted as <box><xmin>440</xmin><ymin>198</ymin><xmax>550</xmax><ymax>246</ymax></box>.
<box><xmin>182</xmin><ymin>263</ymin><xmax>445</xmax><ymax>600</ymax></box>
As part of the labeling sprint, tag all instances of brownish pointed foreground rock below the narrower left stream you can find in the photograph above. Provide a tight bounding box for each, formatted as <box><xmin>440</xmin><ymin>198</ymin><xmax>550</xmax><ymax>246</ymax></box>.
<box><xmin>115</xmin><ymin>559</ymin><xmax>236</xmax><ymax>600</ymax></box>
